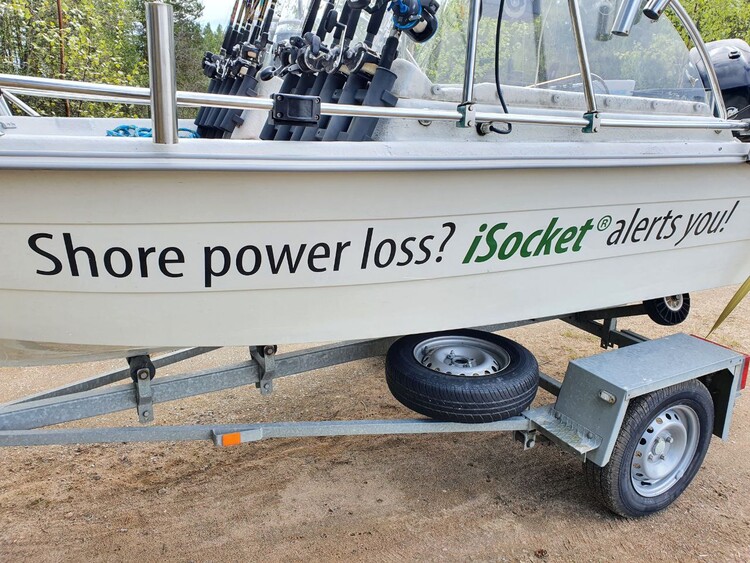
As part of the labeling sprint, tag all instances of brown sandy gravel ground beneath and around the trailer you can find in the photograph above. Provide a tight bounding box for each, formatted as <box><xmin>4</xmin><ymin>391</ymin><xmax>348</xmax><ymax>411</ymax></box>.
<box><xmin>0</xmin><ymin>289</ymin><xmax>750</xmax><ymax>562</ymax></box>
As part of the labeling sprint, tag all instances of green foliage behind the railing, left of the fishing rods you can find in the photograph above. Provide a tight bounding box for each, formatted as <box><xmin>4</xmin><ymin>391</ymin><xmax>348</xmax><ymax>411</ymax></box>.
<box><xmin>0</xmin><ymin>0</ymin><xmax>223</xmax><ymax>117</ymax></box>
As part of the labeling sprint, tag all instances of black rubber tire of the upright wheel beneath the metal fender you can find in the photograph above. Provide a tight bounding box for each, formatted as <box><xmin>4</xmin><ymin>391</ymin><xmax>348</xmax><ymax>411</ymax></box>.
<box><xmin>584</xmin><ymin>380</ymin><xmax>714</xmax><ymax>518</ymax></box>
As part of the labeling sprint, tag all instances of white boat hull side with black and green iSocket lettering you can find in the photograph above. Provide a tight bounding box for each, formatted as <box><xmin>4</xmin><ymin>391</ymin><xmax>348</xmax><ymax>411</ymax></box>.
<box><xmin>0</xmin><ymin>144</ymin><xmax>750</xmax><ymax>366</ymax></box>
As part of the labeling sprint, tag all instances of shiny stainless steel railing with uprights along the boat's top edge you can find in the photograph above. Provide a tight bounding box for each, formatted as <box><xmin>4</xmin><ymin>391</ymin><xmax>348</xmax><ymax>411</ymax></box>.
<box><xmin>0</xmin><ymin>0</ymin><xmax>750</xmax><ymax>144</ymax></box>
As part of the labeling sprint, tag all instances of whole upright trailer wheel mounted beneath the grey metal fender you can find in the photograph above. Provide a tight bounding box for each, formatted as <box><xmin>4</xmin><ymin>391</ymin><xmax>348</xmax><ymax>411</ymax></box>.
<box><xmin>585</xmin><ymin>380</ymin><xmax>714</xmax><ymax>518</ymax></box>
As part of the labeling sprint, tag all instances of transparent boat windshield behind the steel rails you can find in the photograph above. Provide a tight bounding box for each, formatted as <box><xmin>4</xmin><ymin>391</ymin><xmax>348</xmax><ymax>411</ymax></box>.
<box><xmin>409</xmin><ymin>0</ymin><xmax>711</xmax><ymax>115</ymax></box>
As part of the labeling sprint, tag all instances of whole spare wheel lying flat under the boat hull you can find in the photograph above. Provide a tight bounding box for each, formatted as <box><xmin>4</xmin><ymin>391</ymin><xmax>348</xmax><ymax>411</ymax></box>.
<box><xmin>385</xmin><ymin>329</ymin><xmax>539</xmax><ymax>423</ymax></box>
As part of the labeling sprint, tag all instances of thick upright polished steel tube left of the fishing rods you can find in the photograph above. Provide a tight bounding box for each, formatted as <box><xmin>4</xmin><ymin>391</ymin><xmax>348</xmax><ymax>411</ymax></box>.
<box><xmin>146</xmin><ymin>2</ymin><xmax>179</xmax><ymax>145</ymax></box>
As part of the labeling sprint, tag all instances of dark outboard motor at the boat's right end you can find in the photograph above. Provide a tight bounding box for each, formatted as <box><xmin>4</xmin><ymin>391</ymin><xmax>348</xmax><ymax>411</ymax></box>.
<box><xmin>690</xmin><ymin>39</ymin><xmax>750</xmax><ymax>119</ymax></box>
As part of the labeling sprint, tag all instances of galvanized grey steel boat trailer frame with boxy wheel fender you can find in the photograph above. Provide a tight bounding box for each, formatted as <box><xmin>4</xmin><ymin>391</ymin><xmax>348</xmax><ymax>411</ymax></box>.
<box><xmin>0</xmin><ymin>305</ymin><xmax>750</xmax><ymax>516</ymax></box>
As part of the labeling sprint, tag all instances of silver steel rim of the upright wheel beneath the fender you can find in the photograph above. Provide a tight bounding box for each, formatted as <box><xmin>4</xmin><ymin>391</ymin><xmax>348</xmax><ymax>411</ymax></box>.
<box><xmin>630</xmin><ymin>405</ymin><xmax>700</xmax><ymax>497</ymax></box>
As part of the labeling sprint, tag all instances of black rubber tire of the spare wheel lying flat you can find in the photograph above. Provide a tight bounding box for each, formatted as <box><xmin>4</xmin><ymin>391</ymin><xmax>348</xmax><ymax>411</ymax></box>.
<box><xmin>385</xmin><ymin>329</ymin><xmax>539</xmax><ymax>423</ymax></box>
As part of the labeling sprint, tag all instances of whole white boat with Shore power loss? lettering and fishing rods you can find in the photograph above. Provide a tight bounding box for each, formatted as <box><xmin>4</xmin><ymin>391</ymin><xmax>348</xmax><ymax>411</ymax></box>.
<box><xmin>0</xmin><ymin>0</ymin><xmax>750</xmax><ymax>366</ymax></box>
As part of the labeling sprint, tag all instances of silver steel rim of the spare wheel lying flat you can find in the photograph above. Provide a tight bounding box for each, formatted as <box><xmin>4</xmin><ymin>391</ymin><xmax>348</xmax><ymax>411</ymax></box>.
<box><xmin>414</xmin><ymin>335</ymin><xmax>510</xmax><ymax>377</ymax></box>
